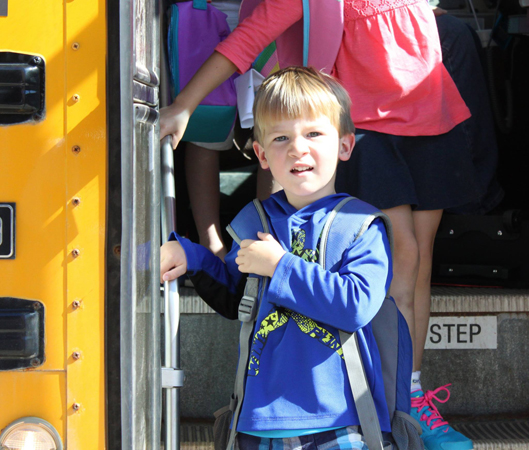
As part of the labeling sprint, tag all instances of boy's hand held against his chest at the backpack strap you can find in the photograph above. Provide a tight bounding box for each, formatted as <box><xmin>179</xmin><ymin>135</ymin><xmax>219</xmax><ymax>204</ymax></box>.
<box><xmin>235</xmin><ymin>232</ymin><xmax>286</xmax><ymax>277</ymax></box>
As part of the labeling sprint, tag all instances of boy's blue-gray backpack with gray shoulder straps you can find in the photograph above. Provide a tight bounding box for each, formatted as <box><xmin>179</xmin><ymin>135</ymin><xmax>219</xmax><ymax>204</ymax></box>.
<box><xmin>214</xmin><ymin>197</ymin><xmax>424</xmax><ymax>450</ymax></box>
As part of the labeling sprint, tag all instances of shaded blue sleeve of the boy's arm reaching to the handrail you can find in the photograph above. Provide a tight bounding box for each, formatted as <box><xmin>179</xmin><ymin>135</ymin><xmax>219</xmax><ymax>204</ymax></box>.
<box><xmin>169</xmin><ymin>233</ymin><xmax>247</xmax><ymax>320</ymax></box>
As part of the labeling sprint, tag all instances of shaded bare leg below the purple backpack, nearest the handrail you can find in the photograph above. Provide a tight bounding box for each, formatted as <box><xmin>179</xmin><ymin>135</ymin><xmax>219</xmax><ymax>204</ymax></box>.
<box><xmin>185</xmin><ymin>142</ymin><xmax>226</xmax><ymax>259</ymax></box>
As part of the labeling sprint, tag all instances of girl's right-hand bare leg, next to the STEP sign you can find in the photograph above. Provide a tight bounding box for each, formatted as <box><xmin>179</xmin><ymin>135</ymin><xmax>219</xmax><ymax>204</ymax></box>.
<box><xmin>412</xmin><ymin>209</ymin><xmax>443</xmax><ymax>370</ymax></box>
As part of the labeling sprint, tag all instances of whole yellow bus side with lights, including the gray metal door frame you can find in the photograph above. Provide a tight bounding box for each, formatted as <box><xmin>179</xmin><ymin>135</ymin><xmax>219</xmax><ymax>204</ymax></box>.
<box><xmin>0</xmin><ymin>0</ymin><xmax>165</xmax><ymax>450</ymax></box>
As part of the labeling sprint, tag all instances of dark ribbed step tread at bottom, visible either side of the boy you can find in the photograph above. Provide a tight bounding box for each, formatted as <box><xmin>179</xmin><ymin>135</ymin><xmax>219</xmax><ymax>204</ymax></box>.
<box><xmin>180</xmin><ymin>419</ymin><xmax>529</xmax><ymax>450</ymax></box>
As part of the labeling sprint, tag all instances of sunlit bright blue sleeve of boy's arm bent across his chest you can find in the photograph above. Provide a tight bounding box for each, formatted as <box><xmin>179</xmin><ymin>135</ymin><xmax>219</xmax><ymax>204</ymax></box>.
<box><xmin>268</xmin><ymin>219</ymin><xmax>391</xmax><ymax>333</ymax></box>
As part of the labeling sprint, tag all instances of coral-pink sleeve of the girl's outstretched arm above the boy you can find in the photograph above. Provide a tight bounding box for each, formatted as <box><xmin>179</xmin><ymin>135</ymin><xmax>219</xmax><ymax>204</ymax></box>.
<box><xmin>215</xmin><ymin>0</ymin><xmax>303</xmax><ymax>73</ymax></box>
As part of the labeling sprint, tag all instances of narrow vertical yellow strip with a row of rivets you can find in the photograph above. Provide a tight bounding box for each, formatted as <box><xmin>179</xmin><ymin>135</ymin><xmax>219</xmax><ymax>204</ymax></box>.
<box><xmin>65</xmin><ymin>1</ymin><xmax>106</xmax><ymax>449</ymax></box>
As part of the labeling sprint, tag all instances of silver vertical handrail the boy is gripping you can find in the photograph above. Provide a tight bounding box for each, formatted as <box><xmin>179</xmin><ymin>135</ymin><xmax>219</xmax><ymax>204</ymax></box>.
<box><xmin>160</xmin><ymin>0</ymin><xmax>184</xmax><ymax>450</ymax></box>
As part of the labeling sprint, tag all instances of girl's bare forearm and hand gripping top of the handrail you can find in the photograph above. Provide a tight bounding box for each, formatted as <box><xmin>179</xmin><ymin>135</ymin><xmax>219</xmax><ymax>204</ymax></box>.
<box><xmin>160</xmin><ymin>52</ymin><xmax>237</xmax><ymax>148</ymax></box>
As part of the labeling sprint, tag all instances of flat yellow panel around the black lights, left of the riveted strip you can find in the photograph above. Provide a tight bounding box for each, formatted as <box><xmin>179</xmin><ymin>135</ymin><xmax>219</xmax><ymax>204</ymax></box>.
<box><xmin>0</xmin><ymin>1</ymin><xmax>66</xmax><ymax>372</ymax></box>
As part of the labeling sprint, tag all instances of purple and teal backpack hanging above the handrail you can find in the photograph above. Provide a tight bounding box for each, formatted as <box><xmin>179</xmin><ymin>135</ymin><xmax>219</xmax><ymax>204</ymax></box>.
<box><xmin>168</xmin><ymin>0</ymin><xmax>237</xmax><ymax>142</ymax></box>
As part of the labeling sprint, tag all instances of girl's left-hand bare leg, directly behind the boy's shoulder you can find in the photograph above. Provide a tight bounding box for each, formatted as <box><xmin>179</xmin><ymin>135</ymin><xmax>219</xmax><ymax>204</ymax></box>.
<box><xmin>382</xmin><ymin>205</ymin><xmax>419</xmax><ymax>371</ymax></box>
